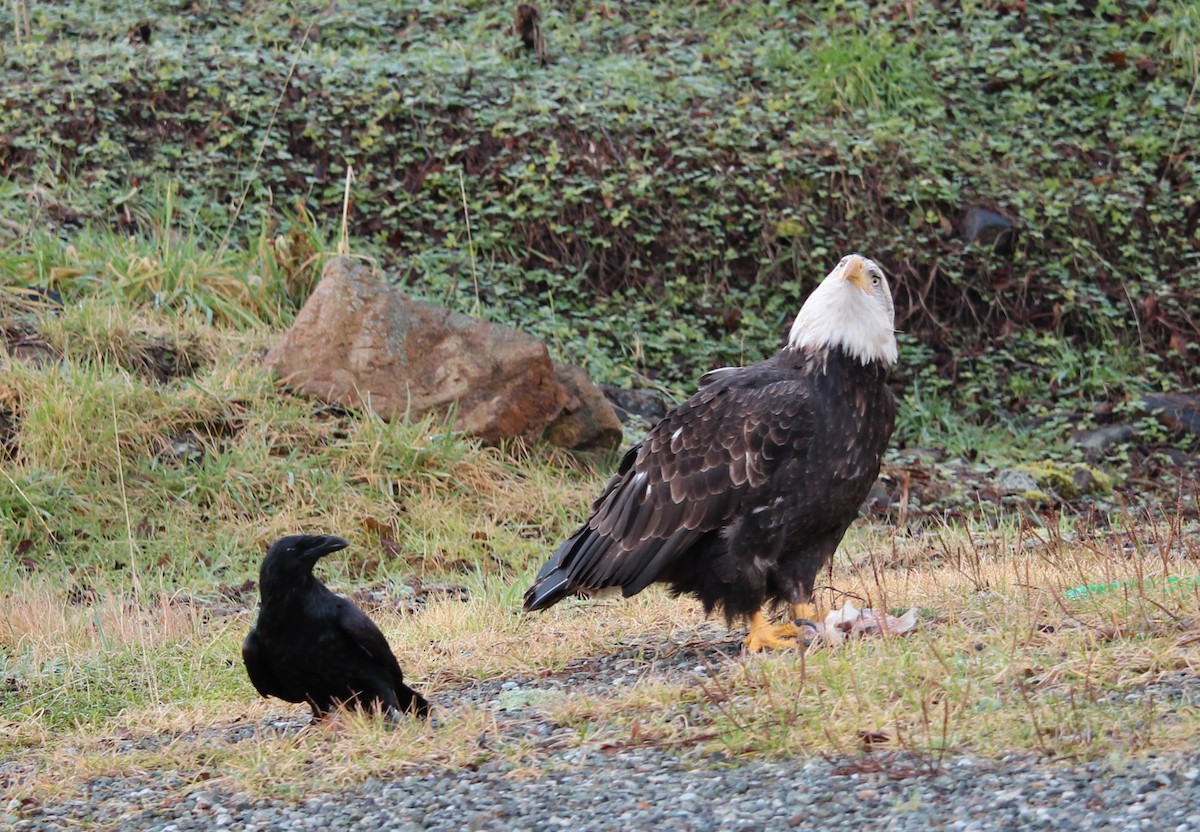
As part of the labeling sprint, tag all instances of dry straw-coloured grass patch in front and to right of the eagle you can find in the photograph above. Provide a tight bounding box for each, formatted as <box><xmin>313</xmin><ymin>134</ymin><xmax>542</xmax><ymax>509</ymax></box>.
<box><xmin>535</xmin><ymin>518</ymin><xmax>1200</xmax><ymax>760</ymax></box>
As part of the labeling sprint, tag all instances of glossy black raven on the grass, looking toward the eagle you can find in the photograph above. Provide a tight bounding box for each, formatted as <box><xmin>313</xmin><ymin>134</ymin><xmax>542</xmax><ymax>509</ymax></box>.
<box><xmin>241</xmin><ymin>534</ymin><xmax>430</xmax><ymax>720</ymax></box>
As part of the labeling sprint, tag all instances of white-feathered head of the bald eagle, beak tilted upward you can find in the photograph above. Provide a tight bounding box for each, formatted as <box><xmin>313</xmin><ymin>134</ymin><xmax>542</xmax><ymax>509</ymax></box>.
<box><xmin>787</xmin><ymin>255</ymin><xmax>896</xmax><ymax>366</ymax></box>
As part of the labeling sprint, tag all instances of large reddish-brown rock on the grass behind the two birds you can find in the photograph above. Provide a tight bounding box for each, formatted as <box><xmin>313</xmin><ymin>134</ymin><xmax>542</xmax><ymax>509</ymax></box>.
<box><xmin>266</xmin><ymin>257</ymin><xmax>571</xmax><ymax>443</ymax></box>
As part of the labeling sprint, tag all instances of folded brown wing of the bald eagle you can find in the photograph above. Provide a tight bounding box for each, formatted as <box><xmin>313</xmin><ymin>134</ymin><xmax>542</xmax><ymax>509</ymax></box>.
<box><xmin>524</xmin><ymin>361</ymin><xmax>814</xmax><ymax>610</ymax></box>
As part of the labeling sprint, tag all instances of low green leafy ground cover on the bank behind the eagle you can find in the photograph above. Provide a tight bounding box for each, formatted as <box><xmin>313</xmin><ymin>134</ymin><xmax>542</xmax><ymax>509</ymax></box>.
<box><xmin>0</xmin><ymin>0</ymin><xmax>1200</xmax><ymax>406</ymax></box>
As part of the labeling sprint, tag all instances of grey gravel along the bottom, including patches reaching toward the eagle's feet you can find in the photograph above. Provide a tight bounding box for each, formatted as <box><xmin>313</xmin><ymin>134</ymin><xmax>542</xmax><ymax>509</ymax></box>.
<box><xmin>7</xmin><ymin>626</ymin><xmax>1200</xmax><ymax>832</ymax></box>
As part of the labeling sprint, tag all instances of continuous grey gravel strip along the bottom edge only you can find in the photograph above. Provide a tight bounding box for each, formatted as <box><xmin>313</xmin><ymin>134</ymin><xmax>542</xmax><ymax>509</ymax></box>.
<box><xmin>9</xmin><ymin>749</ymin><xmax>1200</xmax><ymax>832</ymax></box>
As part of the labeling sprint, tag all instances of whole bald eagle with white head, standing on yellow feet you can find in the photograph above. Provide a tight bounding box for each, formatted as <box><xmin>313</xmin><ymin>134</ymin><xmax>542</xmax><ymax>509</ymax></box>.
<box><xmin>524</xmin><ymin>255</ymin><xmax>896</xmax><ymax>651</ymax></box>
